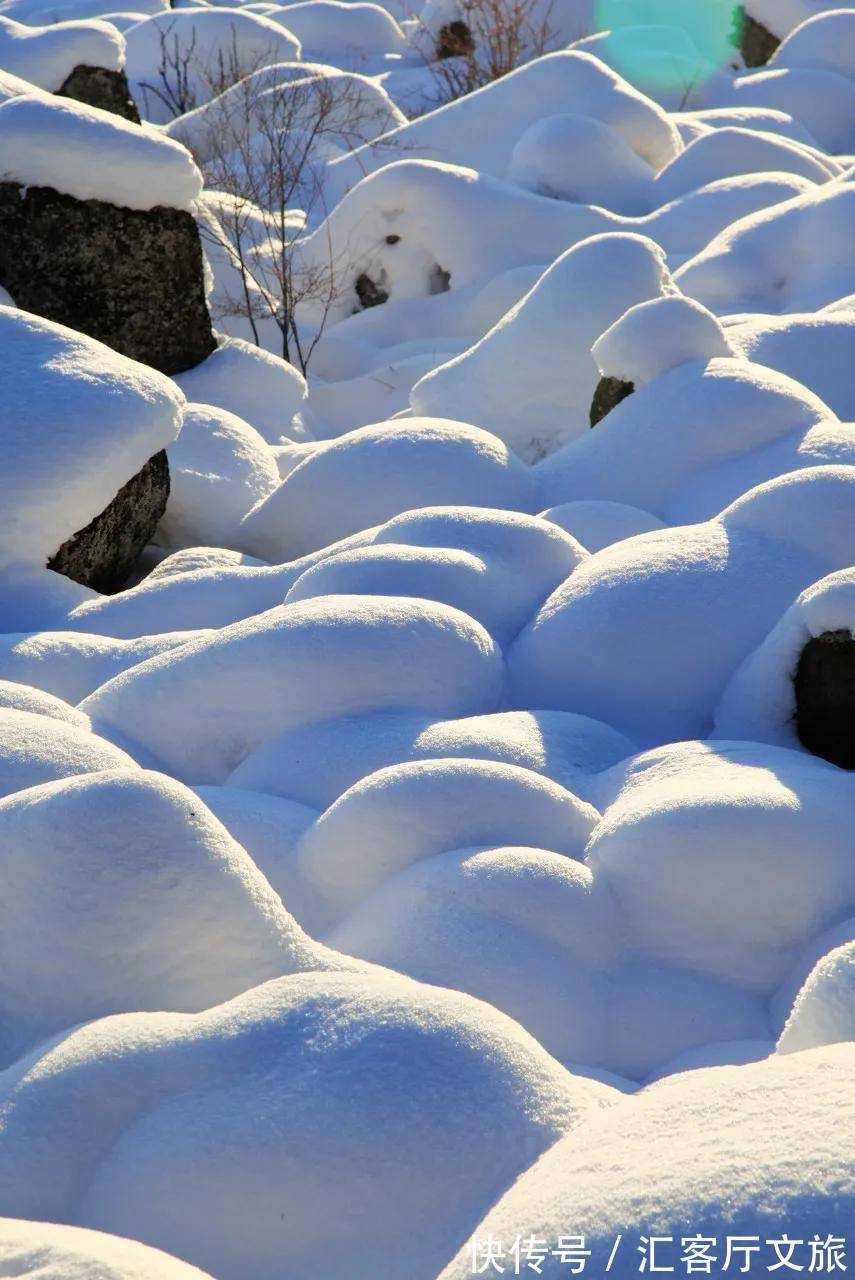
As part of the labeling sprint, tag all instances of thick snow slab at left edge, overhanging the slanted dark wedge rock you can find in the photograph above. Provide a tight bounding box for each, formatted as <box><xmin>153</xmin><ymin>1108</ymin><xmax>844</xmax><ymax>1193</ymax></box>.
<box><xmin>0</xmin><ymin>307</ymin><xmax>183</xmax><ymax>568</ymax></box>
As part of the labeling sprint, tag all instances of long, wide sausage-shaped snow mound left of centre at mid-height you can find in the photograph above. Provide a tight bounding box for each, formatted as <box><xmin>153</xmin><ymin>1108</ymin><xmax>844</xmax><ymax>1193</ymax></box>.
<box><xmin>82</xmin><ymin>595</ymin><xmax>504</xmax><ymax>782</ymax></box>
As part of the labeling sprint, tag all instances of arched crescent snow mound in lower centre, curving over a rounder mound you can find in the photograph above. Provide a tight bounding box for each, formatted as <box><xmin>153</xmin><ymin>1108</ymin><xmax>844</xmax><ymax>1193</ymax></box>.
<box><xmin>297</xmin><ymin>758</ymin><xmax>599</xmax><ymax>933</ymax></box>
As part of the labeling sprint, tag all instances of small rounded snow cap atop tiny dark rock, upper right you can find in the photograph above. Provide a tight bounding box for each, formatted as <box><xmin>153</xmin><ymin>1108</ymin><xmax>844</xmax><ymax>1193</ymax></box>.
<box><xmin>591</xmin><ymin>293</ymin><xmax>736</xmax><ymax>388</ymax></box>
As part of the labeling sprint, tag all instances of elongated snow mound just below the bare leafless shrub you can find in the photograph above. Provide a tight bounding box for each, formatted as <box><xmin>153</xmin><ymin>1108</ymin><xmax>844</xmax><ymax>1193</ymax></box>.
<box><xmin>241</xmin><ymin>416</ymin><xmax>534</xmax><ymax>561</ymax></box>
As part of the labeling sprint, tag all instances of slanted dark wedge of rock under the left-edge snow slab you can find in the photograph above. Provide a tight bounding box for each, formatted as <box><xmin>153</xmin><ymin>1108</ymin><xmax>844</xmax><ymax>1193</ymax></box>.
<box><xmin>47</xmin><ymin>451</ymin><xmax>169</xmax><ymax>594</ymax></box>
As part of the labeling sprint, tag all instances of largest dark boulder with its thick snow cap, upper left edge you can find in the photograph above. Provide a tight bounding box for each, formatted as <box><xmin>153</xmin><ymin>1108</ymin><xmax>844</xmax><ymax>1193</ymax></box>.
<box><xmin>0</xmin><ymin>95</ymin><xmax>215</xmax><ymax>374</ymax></box>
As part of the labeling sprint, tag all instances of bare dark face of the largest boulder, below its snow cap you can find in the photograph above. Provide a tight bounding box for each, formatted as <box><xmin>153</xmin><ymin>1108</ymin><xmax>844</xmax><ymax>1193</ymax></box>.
<box><xmin>0</xmin><ymin>182</ymin><xmax>216</xmax><ymax>374</ymax></box>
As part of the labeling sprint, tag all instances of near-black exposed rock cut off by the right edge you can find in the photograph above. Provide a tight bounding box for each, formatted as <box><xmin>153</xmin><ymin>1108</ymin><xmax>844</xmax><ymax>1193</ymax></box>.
<box><xmin>795</xmin><ymin>631</ymin><xmax>855</xmax><ymax>769</ymax></box>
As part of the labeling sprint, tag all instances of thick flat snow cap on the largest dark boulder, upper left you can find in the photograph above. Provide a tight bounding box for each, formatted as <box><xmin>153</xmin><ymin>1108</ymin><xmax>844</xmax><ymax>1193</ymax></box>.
<box><xmin>0</xmin><ymin>95</ymin><xmax>202</xmax><ymax>209</ymax></box>
